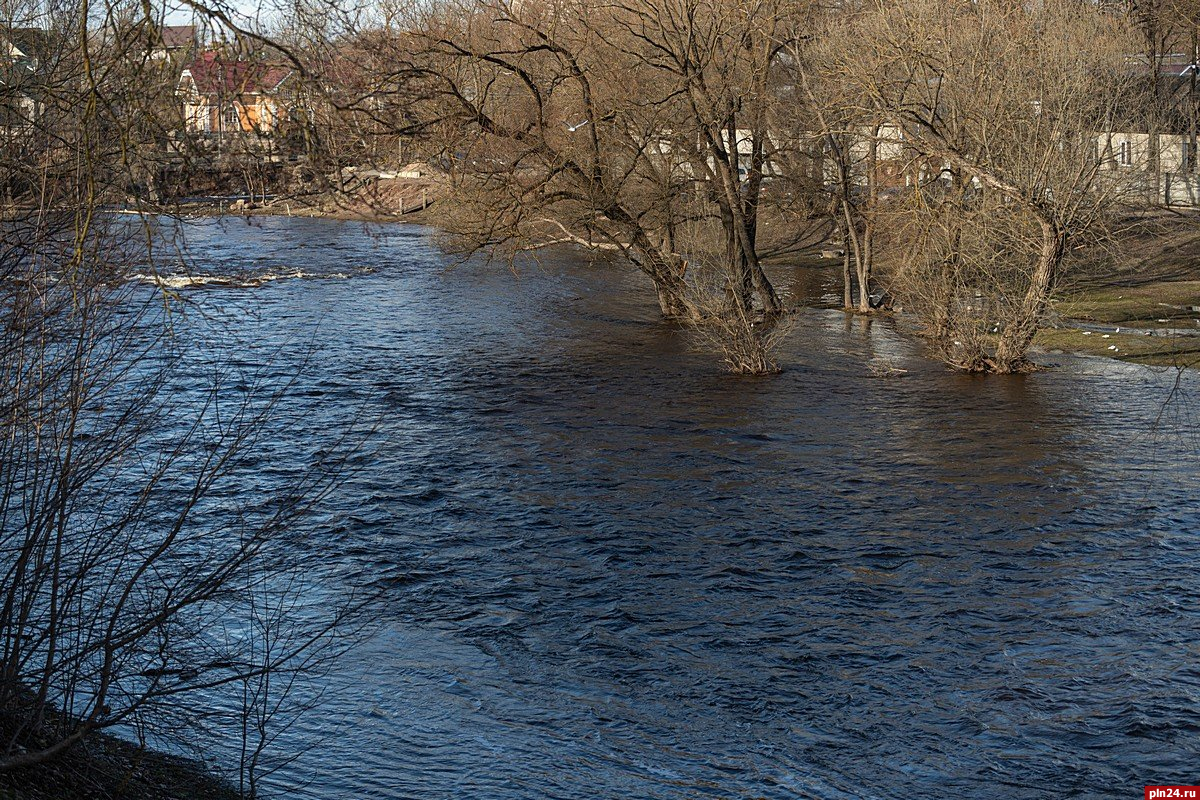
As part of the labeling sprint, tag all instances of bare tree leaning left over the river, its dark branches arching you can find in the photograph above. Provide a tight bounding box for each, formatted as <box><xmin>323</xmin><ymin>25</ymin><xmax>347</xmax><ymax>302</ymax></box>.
<box><xmin>360</xmin><ymin>1</ymin><xmax>697</xmax><ymax>319</ymax></box>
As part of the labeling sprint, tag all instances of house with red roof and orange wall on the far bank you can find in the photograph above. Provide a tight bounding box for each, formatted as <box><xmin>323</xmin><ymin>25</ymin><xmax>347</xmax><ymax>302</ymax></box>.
<box><xmin>175</xmin><ymin>50</ymin><xmax>294</xmax><ymax>136</ymax></box>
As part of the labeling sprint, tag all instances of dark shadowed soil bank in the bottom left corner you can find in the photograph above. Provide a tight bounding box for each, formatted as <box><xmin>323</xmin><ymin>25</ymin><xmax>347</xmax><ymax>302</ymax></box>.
<box><xmin>0</xmin><ymin>734</ymin><xmax>239</xmax><ymax>800</ymax></box>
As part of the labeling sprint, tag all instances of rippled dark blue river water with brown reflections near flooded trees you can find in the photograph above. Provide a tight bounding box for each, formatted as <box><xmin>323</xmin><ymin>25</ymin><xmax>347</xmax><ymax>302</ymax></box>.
<box><xmin>152</xmin><ymin>218</ymin><xmax>1200</xmax><ymax>800</ymax></box>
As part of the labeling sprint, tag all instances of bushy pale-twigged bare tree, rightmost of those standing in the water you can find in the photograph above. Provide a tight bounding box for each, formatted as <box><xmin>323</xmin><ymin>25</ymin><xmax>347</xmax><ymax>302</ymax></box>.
<box><xmin>836</xmin><ymin>0</ymin><xmax>1133</xmax><ymax>372</ymax></box>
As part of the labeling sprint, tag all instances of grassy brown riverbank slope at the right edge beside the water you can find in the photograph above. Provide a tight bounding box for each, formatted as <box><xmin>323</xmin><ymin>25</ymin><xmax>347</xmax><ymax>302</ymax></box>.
<box><xmin>1034</xmin><ymin>211</ymin><xmax>1200</xmax><ymax>367</ymax></box>
